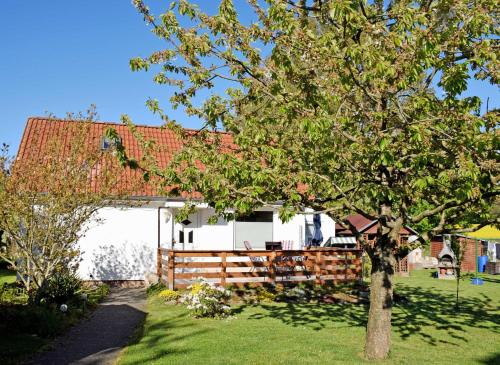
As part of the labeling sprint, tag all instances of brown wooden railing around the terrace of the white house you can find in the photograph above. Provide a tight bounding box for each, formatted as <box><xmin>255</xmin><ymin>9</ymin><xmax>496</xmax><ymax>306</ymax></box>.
<box><xmin>157</xmin><ymin>248</ymin><xmax>362</xmax><ymax>289</ymax></box>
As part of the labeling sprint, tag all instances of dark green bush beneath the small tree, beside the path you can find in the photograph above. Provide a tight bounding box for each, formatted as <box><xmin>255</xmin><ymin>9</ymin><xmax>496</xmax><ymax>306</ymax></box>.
<box><xmin>36</xmin><ymin>272</ymin><xmax>82</xmax><ymax>304</ymax></box>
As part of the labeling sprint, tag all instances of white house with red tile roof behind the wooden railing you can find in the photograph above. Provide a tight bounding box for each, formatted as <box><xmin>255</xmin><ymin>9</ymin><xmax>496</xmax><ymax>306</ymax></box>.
<box><xmin>17</xmin><ymin>118</ymin><xmax>335</xmax><ymax>281</ymax></box>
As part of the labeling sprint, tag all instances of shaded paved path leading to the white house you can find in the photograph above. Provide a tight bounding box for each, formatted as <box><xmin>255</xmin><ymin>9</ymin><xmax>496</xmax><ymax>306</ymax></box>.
<box><xmin>28</xmin><ymin>288</ymin><xmax>146</xmax><ymax>365</ymax></box>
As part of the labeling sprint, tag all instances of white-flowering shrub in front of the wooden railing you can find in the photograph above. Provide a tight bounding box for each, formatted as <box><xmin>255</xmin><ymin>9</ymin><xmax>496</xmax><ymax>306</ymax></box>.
<box><xmin>181</xmin><ymin>279</ymin><xmax>231</xmax><ymax>318</ymax></box>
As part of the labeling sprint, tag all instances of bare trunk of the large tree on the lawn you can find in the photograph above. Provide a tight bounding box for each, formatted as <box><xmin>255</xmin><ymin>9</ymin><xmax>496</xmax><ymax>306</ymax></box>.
<box><xmin>365</xmin><ymin>237</ymin><xmax>396</xmax><ymax>360</ymax></box>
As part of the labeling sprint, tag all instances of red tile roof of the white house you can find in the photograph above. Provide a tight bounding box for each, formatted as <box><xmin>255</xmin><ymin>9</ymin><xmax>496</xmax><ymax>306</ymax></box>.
<box><xmin>17</xmin><ymin>117</ymin><xmax>232</xmax><ymax>198</ymax></box>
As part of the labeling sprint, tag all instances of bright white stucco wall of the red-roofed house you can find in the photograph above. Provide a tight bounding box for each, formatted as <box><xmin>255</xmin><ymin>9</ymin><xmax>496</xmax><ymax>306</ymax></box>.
<box><xmin>79</xmin><ymin>202</ymin><xmax>335</xmax><ymax>280</ymax></box>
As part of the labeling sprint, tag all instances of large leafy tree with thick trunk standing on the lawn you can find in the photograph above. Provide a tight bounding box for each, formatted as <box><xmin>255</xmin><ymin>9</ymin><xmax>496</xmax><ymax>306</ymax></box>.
<box><xmin>122</xmin><ymin>0</ymin><xmax>499</xmax><ymax>359</ymax></box>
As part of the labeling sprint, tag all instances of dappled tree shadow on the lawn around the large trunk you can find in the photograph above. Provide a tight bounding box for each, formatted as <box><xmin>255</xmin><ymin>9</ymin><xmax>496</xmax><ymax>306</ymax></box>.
<box><xmin>244</xmin><ymin>284</ymin><xmax>500</xmax><ymax>346</ymax></box>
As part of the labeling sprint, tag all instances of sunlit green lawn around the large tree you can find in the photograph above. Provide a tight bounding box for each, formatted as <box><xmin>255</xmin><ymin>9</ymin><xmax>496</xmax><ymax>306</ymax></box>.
<box><xmin>119</xmin><ymin>271</ymin><xmax>500</xmax><ymax>365</ymax></box>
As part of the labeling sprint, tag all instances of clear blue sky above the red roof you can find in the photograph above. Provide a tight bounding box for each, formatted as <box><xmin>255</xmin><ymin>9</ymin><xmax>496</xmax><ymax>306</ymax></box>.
<box><xmin>0</xmin><ymin>0</ymin><xmax>500</xmax><ymax>153</ymax></box>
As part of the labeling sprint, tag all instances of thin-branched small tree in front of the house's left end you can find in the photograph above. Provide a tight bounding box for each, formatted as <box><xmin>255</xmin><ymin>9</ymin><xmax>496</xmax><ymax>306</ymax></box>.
<box><xmin>0</xmin><ymin>111</ymin><xmax>124</xmax><ymax>295</ymax></box>
